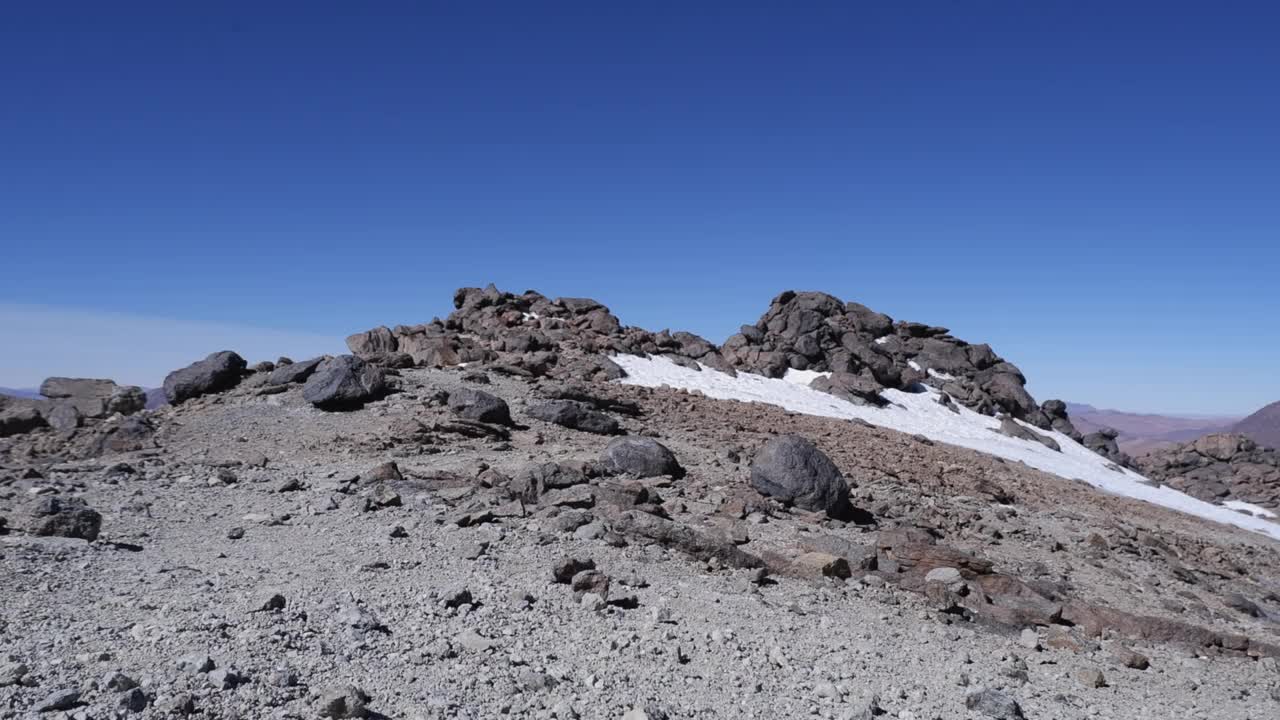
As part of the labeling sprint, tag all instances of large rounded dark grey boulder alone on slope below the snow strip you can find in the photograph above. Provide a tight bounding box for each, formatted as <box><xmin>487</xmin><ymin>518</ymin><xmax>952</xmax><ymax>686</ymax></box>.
<box><xmin>751</xmin><ymin>436</ymin><xmax>851</xmax><ymax>519</ymax></box>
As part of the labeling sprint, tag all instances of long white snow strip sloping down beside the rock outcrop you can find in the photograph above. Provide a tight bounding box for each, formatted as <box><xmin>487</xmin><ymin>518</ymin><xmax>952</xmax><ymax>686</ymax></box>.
<box><xmin>612</xmin><ymin>355</ymin><xmax>1280</xmax><ymax>539</ymax></box>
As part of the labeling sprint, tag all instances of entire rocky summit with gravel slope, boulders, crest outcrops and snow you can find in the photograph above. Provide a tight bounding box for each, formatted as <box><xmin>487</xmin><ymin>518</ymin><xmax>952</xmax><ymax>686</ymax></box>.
<box><xmin>0</xmin><ymin>286</ymin><xmax>1280</xmax><ymax>720</ymax></box>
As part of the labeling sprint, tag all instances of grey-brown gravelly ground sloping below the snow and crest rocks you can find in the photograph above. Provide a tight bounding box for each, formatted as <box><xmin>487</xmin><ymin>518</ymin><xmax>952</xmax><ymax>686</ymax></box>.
<box><xmin>0</xmin><ymin>366</ymin><xmax>1280</xmax><ymax>720</ymax></box>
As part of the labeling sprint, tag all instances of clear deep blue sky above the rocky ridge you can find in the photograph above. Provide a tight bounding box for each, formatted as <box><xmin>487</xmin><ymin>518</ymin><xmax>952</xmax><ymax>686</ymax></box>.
<box><xmin>0</xmin><ymin>0</ymin><xmax>1280</xmax><ymax>413</ymax></box>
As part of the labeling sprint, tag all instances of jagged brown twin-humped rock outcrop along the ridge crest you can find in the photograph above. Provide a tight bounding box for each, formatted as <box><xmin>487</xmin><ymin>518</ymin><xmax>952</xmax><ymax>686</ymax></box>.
<box><xmin>347</xmin><ymin>284</ymin><xmax>1082</xmax><ymax>439</ymax></box>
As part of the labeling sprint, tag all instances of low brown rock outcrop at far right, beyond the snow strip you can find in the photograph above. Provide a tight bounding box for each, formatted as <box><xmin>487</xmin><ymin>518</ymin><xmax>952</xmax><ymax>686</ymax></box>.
<box><xmin>1139</xmin><ymin>433</ymin><xmax>1280</xmax><ymax>510</ymax></box>
